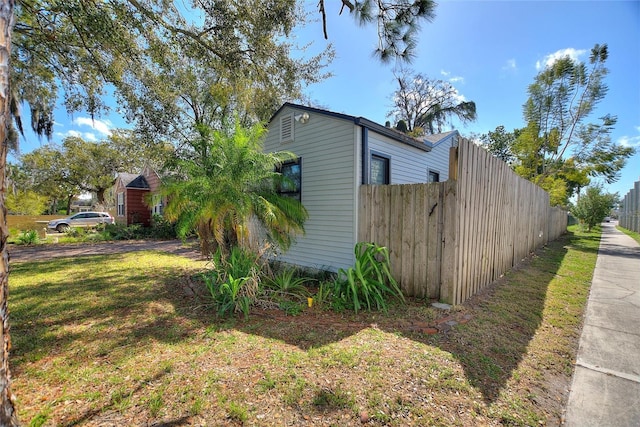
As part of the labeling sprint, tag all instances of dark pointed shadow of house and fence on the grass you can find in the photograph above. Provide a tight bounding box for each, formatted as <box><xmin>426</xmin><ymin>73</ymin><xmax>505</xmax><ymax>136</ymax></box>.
<box><xmin>220</xmin><ymin>229</ymin><xmax>584</xmax><ymax>403</ymax></box>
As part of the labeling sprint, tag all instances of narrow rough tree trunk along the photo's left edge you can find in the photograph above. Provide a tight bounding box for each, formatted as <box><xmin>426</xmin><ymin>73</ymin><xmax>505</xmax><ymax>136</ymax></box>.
<box><xmin>0</xmin><ymin>0</ymin><xmax>20</xmax><ymax>427</ymax></box>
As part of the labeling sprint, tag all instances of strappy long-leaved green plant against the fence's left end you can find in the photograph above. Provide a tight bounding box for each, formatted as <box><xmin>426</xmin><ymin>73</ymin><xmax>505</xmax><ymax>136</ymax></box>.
<box><xmin>332</xmin><ymin>242</ymin><xmax>404</xmax><ymax>313</ymax></box>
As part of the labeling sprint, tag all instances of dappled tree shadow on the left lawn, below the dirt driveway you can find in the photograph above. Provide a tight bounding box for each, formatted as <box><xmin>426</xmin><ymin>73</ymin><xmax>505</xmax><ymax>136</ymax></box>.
<box><xmin>10</xmin><ymin>254</ymin><xmax>205</xmax><ymax>373</ymax></box>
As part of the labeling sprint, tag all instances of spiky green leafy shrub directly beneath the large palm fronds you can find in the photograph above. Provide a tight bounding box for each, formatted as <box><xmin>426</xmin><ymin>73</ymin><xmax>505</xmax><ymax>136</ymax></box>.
<box><xmin>204</xmin><ymin>246</ymin><xmax>261</xmax><ymax>318</ymax></box>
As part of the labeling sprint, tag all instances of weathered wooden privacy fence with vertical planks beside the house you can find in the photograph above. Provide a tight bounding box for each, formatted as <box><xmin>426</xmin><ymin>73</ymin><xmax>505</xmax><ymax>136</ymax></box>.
<box><xmin>358</xmin><ymin>140</ymin><xmax>567</xmax><ymax>304</ymax></box>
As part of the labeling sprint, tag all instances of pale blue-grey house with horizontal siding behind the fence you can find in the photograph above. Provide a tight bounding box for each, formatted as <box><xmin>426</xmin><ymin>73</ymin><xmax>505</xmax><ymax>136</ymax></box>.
<box><xmin>264</xmin><ymin>103</ymin><xmax>459</xmax><ymax>271</ymax></box>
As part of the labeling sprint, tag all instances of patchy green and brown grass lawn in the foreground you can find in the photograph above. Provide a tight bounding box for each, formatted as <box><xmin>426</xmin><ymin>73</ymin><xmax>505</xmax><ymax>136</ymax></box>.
<box><xmin>9</xmin><ymin>226</ymin><xmax>599</xmax><ymax>426</ymax></box>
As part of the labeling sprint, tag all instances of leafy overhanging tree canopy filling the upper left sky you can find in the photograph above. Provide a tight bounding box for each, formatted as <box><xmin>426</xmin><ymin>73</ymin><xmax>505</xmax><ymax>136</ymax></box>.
<box><xmin>12</xmin><ymin>0</ymin><xmax>332</xmax><ymax>142</ymax></box>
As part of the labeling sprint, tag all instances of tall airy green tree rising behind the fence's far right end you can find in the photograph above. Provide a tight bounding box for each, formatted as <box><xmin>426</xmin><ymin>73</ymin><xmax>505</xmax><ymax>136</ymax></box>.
<box><xmin>481</xmin><ymin>44</ymin><xmax>635</xmax><ymax>206</ymax></box>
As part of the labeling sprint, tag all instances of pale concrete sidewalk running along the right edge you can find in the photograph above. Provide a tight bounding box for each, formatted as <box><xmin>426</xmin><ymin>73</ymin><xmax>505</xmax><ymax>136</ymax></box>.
<box><xmin>565</xmin><ymin>223</ymin><xmax>640</xmax><ymax>427</ymax></box>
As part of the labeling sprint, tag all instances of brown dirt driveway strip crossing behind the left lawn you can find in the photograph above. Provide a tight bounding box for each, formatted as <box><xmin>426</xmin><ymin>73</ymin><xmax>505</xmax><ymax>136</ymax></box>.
<box><xmin>8</xmin><ymin>240</ymin><xmax>204</xmax><ymax>262</ymax></box>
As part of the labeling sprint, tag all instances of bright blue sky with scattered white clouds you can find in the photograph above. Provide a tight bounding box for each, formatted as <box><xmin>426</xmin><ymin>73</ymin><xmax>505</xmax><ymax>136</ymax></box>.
<box><xmin>15</xmin><ymin>0</ymin><xmax>640</xmax><ymax>196</ymax></box>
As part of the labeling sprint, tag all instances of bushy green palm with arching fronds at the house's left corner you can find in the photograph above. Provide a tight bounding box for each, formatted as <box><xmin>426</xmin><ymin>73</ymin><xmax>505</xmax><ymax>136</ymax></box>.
<box><xmin>160</xmin><ymin>122</ymin><xmax>308</xmax><ymax>256</ymax></box>
